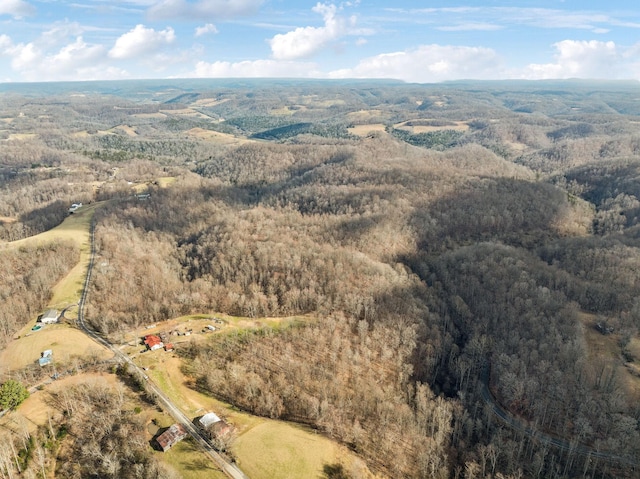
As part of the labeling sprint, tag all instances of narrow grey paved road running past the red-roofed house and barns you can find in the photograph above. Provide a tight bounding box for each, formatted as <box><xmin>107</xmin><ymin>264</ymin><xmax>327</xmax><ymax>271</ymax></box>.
<box><xmin>78</xmin><ymin>220</ymin><xmax>249</xmax><ymax>479</ymax></box>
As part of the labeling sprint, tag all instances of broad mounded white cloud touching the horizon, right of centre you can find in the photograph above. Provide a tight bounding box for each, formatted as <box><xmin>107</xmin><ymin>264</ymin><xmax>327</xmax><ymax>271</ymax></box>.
<box><xmin>329</xmin><ymin>45</ymin><xmax>503</xmax><ymax>83</ymax></box>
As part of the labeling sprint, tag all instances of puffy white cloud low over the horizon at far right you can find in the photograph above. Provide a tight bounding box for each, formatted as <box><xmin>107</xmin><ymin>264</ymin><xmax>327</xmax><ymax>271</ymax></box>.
<box><xmin>520</xmin><ymin>40</ymin><xmax>626</xmax><ymax>80</ymax></box>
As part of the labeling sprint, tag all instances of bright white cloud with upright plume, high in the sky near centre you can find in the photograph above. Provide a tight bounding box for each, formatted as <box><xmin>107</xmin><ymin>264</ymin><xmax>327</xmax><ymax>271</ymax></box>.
<box><xmin>269</xmin><ymin>3</ymin><xmax>363</xmax><ymax>60</ymax></box>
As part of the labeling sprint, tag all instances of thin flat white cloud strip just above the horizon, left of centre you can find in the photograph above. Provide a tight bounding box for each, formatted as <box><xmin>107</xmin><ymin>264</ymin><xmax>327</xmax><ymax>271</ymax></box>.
<box><xmin>189</xmin><ymin>60</ymin><xmax>322</xmax><ymax>78</ymax></box>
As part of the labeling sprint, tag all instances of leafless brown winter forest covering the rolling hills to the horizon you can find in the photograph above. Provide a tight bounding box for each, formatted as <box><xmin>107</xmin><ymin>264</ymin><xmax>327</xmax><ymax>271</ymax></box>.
<box><xmin>0</xmin><ymin>81</ymin><xmax>640</xmax><ymax>479</ymax></box>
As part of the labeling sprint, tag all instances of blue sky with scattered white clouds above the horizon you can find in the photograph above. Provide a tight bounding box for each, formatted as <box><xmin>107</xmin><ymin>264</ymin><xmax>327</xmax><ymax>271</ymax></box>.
<box><xmin>0</xmin><ymin>0</ymin><xmax>640</xmax><ymax>83</ymax></box>
